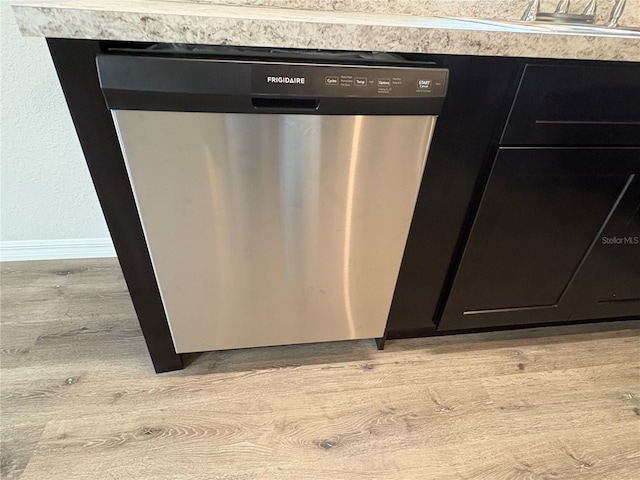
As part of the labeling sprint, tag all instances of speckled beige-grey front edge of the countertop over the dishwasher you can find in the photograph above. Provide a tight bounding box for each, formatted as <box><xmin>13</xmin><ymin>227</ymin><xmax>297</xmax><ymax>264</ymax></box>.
<box><xmin>12</xmin><ymin>4</ymin><xmax>640</xmax><ymax>62</ymax></box>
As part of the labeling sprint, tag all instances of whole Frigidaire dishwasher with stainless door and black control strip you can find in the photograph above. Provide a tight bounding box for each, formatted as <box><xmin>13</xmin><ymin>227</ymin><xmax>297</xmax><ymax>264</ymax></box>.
<box><xmin>97</xmin><ymin>50</ymin><xmax>448</xmax><ymax>353</ymax></box>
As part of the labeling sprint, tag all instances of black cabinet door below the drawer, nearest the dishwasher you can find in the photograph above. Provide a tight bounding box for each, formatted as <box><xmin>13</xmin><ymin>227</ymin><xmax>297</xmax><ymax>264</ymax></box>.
<box><xmin>438</xmin><ymin>148</ymin><xmax>640</xmax><ymax>330</ymax></box>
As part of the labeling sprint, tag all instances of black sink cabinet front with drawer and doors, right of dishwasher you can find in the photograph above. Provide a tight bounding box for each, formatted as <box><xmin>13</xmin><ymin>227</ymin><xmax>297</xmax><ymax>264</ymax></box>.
<box><xmin>438</xmin><ymin>65</ymin><xmax>640</xmax><ymax>331</ymax></box>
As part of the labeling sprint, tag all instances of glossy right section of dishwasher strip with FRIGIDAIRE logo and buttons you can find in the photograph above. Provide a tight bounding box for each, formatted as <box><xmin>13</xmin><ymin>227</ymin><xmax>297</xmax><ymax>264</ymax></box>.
<box><xmin>251</xmin><ymin>63</ymin><xmax>448</xmax><ymax>98</ymax></box>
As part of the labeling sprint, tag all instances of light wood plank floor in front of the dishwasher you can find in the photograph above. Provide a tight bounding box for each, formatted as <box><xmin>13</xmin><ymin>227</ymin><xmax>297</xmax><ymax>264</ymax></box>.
<box><xmin>1</xmin><ymin>259</ymin><xmax>640</xmax><ymax>480</ymax></box>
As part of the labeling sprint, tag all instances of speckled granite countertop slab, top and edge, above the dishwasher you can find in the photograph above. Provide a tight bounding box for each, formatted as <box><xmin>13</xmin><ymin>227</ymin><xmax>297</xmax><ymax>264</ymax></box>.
<box><xmin>13</xmin><ymin>0</ymin><xmax>640</xmax><ymax>61</ymax></box>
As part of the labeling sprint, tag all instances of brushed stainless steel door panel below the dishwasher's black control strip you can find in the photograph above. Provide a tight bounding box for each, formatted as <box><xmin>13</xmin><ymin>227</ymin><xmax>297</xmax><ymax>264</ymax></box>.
<box><xmin>113</xmin><ymin>110</ymin><xmax>436</xmax><ymax>353</ymax></box>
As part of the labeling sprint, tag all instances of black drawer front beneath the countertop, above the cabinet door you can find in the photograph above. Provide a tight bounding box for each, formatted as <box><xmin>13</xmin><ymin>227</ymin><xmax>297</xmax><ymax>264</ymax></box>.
<box><xmin>501</xmin><ymin>65</ymin><xmax>640</xmax><ymax>145</ymax></box>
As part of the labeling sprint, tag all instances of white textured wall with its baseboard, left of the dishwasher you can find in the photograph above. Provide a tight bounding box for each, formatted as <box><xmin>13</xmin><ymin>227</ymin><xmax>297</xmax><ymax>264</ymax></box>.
<box><xmin>0</xmin><ymin>0</ymin><xmax>113</xmax><ymax>260</ymax></box>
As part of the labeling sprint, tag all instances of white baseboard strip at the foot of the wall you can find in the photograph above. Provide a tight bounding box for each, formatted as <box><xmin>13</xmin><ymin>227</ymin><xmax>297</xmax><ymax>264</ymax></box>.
<box><xmin>0</xmin><ymin>238</ymin><xmax>116</xmax><ymax>262</ymax></box>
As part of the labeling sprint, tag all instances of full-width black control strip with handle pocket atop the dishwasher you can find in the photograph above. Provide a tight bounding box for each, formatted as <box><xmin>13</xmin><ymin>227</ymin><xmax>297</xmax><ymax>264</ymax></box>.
<box><xmin>96</xmin><ymin>54</ymin><xmax>449</xmax><ymax>115</ymax></box>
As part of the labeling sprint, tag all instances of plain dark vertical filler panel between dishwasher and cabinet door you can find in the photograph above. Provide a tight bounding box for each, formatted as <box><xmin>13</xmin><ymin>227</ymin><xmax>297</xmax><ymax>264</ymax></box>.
<box><xmin>386</xmin><ymin>56</ymin><xmax>522</xmax><ymax>338</ymax></box>
